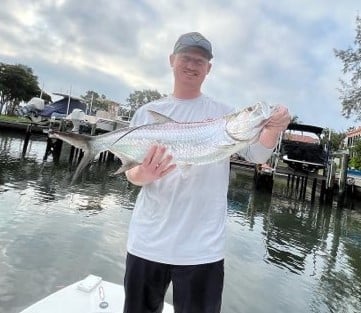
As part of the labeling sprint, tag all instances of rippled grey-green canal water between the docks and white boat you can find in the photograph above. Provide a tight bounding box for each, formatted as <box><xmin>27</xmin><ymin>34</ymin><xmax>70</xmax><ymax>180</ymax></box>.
<box><xmin>0</xmin><ymin>130</ymin><xmax>361</xmax><ymax>313</ymax></box>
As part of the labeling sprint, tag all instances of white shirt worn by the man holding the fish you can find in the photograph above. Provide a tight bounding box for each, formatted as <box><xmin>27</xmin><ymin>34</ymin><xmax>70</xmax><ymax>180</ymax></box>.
<box><xmin>127</xmin><ymin>95</ymin><xmax>272</xmax><ymax>265</ymax></box>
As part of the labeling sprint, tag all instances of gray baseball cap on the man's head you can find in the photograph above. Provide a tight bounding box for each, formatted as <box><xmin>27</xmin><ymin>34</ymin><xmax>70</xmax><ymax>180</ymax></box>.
<box><xmin>173</xmin><ymin>32</ymin><xmax>213</xmax><ymax>60</ymax></box>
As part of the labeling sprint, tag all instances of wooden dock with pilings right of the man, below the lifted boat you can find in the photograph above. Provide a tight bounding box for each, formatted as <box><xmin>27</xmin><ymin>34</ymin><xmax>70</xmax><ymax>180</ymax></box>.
<box><xmin>230</xmin><ymin>151</ymin><xmax>352</xmax><ymax>206</ymax></box>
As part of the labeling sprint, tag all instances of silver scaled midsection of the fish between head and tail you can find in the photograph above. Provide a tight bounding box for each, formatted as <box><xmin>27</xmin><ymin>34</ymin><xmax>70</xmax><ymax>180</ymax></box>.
<box><xmin>109</xmin><ymin>119</ymin><xmax>239</xmax><ymax>164</ymax></box>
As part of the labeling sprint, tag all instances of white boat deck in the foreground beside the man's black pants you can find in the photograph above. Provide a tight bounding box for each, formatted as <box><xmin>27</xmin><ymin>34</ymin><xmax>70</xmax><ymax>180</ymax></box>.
<box><xmin>20</xmin><ymin>274</ymin><xmax>174</xmax><ymax>313</ymax></box>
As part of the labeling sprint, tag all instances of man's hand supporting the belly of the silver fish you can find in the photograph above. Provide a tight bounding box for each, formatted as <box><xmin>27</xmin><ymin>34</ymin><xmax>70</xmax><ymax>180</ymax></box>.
<box><xmin>125</xmin><ymin>145</ymin><xmax>176</xmax><ymax>186</ymax></box>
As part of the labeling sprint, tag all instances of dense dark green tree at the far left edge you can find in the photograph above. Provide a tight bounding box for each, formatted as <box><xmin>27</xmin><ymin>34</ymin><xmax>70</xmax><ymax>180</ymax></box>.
<box><xmin>0</xmin><ymin>63</ymin><xmax>41</xmax><ymax>114</ymax></box>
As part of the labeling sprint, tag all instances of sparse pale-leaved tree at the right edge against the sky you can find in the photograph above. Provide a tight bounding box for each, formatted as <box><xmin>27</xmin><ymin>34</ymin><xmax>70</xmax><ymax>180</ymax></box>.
<box><xmin>334</xmin><ymin>16</ymin><xmax>361</xmax><ymax>120</ymax></box>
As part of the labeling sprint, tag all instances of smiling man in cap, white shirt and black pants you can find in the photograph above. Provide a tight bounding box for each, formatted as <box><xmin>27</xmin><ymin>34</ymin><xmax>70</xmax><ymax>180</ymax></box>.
<box><xmin>124</xmin><ymin>32</ymin><xmax>290</xmax><ymax>313</ymax></box>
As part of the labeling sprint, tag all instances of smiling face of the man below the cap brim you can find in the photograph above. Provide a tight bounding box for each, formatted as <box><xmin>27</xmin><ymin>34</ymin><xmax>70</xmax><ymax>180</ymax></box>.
<box><xmin>170</xmin><ymin>48</ymin><xmax>212</xmax><ymax>88</ymax></box>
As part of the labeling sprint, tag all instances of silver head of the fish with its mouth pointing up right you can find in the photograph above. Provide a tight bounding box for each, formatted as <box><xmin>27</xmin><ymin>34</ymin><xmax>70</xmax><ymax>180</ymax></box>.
<box><xmin>226</xmin><ymin>102</ymin><xmax>274</xmax><ymax>141</ymax></box>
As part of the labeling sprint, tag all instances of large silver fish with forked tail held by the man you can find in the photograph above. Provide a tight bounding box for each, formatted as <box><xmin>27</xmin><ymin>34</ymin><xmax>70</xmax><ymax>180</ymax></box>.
<box><xmin>50</xmin><ymin>102</ymin><xmax>275</xmax><ymax>182</ymax></box>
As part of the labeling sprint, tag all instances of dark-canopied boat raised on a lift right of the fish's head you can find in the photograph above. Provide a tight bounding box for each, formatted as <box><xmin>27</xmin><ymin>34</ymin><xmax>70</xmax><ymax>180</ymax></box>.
<box><xmin>280</xmin><ymin>123</ymin><xmax>328</xmax><ymax>173</ymax></box>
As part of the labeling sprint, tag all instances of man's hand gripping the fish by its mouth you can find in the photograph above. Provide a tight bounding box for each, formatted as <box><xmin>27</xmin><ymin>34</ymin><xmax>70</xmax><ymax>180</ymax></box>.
<box><xmin>259</xmin><ymin>105</ymin><xmax>291</xmax><ymax>148</ymax></box>
